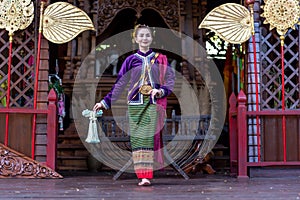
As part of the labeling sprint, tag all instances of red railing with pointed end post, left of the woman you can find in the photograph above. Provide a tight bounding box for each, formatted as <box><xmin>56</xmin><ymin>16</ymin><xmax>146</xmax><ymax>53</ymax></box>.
<box><xmin>0</xmin><ymin>89</ymin><xmax>58</xmax><ymax>170</ymax></box>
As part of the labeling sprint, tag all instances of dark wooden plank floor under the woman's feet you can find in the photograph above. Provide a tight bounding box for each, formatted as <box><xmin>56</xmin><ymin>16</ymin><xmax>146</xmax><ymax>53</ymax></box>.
<box><xmin>0</xmin><ymin>169</ymin><xmax>300</xmax><ymax>200</ymax></box>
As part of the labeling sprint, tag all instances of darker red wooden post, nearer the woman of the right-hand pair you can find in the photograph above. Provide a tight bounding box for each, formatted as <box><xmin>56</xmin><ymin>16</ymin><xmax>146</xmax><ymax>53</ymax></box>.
<box><xmin>229</xmin><ymin>93</ymin><xmax>238</xmax><ymax>175</ymax></box>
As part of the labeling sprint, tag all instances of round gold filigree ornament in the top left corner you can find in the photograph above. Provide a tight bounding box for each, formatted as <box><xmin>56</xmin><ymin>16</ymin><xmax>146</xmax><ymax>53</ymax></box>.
<box><xmin>0</xmin><ymin>0</ymin><xmax>34</xmax><ymax>35</ymax></box>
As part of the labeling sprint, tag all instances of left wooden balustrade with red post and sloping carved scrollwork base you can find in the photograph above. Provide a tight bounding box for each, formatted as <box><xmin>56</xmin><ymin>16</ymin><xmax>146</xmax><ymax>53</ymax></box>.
<box><xmin>0</xmin><ymin>89</ymin><xmax>62</xmax><ymax>178</ymax></box>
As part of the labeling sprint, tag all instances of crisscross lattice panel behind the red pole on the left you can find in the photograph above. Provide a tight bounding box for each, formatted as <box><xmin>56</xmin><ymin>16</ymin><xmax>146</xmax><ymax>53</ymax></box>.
<box><xmin>0</xmin><ymin>27</ymin><xmax>34</xmax><ymax>107</ymax></box>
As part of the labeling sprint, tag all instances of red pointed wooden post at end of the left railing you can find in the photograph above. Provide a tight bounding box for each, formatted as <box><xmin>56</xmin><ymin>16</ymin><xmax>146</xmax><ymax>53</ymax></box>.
<box><xmin>47</xmin><ymin>89</ymin><xmax>57</xmax><ymax>170</ymax></box>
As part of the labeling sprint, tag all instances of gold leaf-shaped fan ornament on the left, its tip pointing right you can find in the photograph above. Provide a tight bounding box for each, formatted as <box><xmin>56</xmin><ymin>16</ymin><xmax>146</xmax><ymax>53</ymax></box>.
<box><xmin>43</xmin><ymin>2</ymin><xmax>95</xmax><ymax>44</ymax></box>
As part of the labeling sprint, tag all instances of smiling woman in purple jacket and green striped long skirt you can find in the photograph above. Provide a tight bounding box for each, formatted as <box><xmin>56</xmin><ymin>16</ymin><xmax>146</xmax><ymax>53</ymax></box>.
<box><xmin>93</xmin><ymin>25</ymin><xmax>175</xmax><ymax>186</ymax></box>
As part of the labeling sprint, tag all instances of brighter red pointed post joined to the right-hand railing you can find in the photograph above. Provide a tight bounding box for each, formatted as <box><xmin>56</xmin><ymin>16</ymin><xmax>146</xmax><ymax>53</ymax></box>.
<box><xmin>237</xmin><ymin>90</ymin><xmax>248</xmax><ymax>178</ymax></box>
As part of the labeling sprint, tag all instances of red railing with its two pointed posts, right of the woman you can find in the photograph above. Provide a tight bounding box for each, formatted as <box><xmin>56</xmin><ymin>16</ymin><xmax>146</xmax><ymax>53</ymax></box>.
<box><xmin>229</xmin><ymin>90</ymin><xmax>300</xmax><ymax>178</ymax></box>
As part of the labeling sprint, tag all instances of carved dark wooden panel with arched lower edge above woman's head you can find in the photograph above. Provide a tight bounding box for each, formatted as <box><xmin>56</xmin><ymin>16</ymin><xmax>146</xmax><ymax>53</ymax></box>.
<box><xmin>97</xmin><ymin>0</ymin><xmax>179</xmax><ymax>35</ymax></box>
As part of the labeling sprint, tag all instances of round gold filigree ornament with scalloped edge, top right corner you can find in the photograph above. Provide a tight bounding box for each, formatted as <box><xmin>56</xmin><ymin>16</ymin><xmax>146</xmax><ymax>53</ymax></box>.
<box><xmin>261</xmin><ymin>0</ymin><xmax>300</xmax><ymax>36</ymax></box>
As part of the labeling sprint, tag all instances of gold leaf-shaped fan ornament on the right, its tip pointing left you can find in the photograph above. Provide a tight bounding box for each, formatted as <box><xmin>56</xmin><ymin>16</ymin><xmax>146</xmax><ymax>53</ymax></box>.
<box><xmin>199</xmin><ymin>3</ymin><xmax>253</xmax><ymax>44</ymax></box>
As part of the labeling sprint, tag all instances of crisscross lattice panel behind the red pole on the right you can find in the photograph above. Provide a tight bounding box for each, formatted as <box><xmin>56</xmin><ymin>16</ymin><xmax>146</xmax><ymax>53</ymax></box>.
<box><xmin>261</xmin><ymin>26</ymin><xmax>300</xmax><ymax>109</ymax></box>
